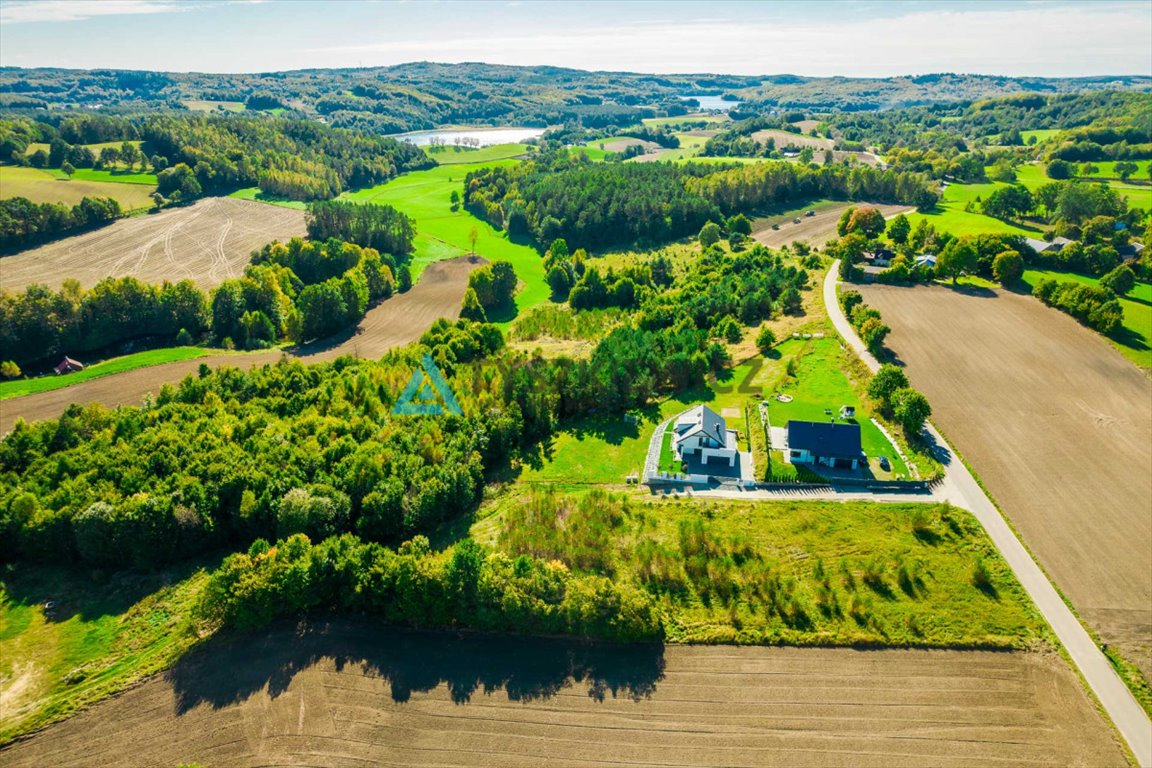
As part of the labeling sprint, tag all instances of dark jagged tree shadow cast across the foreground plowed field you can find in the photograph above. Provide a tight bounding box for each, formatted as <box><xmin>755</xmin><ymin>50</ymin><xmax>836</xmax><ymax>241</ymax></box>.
<box><xmin>166</xmin><ymin>618</ymin><xmax>665</xmax><ymax>715</ymax></box>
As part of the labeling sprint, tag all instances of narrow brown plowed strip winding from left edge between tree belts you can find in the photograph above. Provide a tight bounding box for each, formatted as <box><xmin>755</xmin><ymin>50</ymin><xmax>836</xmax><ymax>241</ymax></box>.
<box><xmin>0</xmin><ymin>257</ymin><xmax>484</xmax><ymax>434</ymax></box>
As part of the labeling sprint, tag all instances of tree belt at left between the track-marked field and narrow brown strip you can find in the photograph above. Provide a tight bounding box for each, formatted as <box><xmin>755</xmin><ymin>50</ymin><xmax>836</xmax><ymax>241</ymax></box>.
<box><xmin>0</xmin><ymin>238</ymin><xmax>395</xmax><ymax>367</ymax></box>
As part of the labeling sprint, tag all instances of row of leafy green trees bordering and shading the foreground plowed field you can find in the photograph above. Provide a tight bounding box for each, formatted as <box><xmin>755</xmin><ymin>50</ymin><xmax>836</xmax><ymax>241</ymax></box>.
<box><xmin>198</xmin><ymin>534</ymin><xmax>664</xmax><ymax>641</ymax></box>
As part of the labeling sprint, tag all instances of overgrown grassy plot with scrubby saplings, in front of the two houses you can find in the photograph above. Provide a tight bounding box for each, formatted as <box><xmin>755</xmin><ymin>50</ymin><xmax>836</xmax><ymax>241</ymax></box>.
<box><xmin>472</xmin><ymin>489</ymin><xmax>1048</xmax><ymax>648</ymax></box>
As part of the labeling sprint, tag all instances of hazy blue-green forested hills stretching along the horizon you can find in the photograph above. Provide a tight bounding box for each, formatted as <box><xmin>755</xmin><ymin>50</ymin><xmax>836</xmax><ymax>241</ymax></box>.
<box><xmin>0</xmin><ymin>62</ymin><xmax>1152</xmax><ymax>132</ymax></box>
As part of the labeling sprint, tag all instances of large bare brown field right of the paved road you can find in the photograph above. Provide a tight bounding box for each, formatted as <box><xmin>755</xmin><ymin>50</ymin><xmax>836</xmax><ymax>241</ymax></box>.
<box><xmin>861</xmin><ymin>286</ymin><xmax>1152</xmax><ymax>679</ymax></box>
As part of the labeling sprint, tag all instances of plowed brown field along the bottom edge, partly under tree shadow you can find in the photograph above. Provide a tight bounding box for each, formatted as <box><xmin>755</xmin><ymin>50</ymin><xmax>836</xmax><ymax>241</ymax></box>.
<box><xmin>2</xmin><ymin>622</ymin><xmax>1124</xmax><ymax>768</ymax></box>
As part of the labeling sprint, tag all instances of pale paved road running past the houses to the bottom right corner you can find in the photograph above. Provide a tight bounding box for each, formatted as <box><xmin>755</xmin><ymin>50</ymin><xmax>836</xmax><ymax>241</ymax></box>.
<box><xmin>824</xmin><ymin>261</ymin><xmax>1152</xmax><ymax>768</ymax></box>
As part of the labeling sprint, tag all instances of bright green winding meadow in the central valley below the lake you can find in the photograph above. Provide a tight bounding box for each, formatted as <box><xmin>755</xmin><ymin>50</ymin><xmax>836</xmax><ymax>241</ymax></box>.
<box><xmin>341</xmin><ymin>159</ymin><xmax>551</xmax><ymax>328</ymax></box>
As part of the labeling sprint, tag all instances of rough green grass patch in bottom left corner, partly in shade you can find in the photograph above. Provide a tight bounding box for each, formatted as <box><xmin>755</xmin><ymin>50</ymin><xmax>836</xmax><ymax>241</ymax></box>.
<box><xmin>0</xmin><ymin>565</ymin><xmax>205</xmax><ymax>744</ymax></box>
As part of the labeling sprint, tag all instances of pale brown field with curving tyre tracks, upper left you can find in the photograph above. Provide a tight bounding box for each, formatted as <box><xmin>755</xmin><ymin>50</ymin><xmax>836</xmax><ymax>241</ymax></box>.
<box><xmin>0</xmin><ymin>197</ymin><xmax>304</xmax><ymax>290</ymax></box>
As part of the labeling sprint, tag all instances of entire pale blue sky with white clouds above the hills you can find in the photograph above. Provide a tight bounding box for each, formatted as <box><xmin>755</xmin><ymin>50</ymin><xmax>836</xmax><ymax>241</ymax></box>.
<box><xmin>0</xmin><ymin>0</ymin><xmax>1152</xmax><ymax>77</ymax></box>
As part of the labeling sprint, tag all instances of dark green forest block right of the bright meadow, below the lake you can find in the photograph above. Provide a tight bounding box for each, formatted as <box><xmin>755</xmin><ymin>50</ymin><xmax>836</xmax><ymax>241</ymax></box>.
<box><xmin>464</xmin><ymin>154</ymin><xmax>937</xmax><ymax>249</ymax></box>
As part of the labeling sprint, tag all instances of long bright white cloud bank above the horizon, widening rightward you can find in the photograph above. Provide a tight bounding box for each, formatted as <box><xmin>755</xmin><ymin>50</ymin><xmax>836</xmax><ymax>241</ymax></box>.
<box><xmin>304</xmin><ymin>3</ymin><xmax>1152</xmax><ymax>77</ymax></box>
